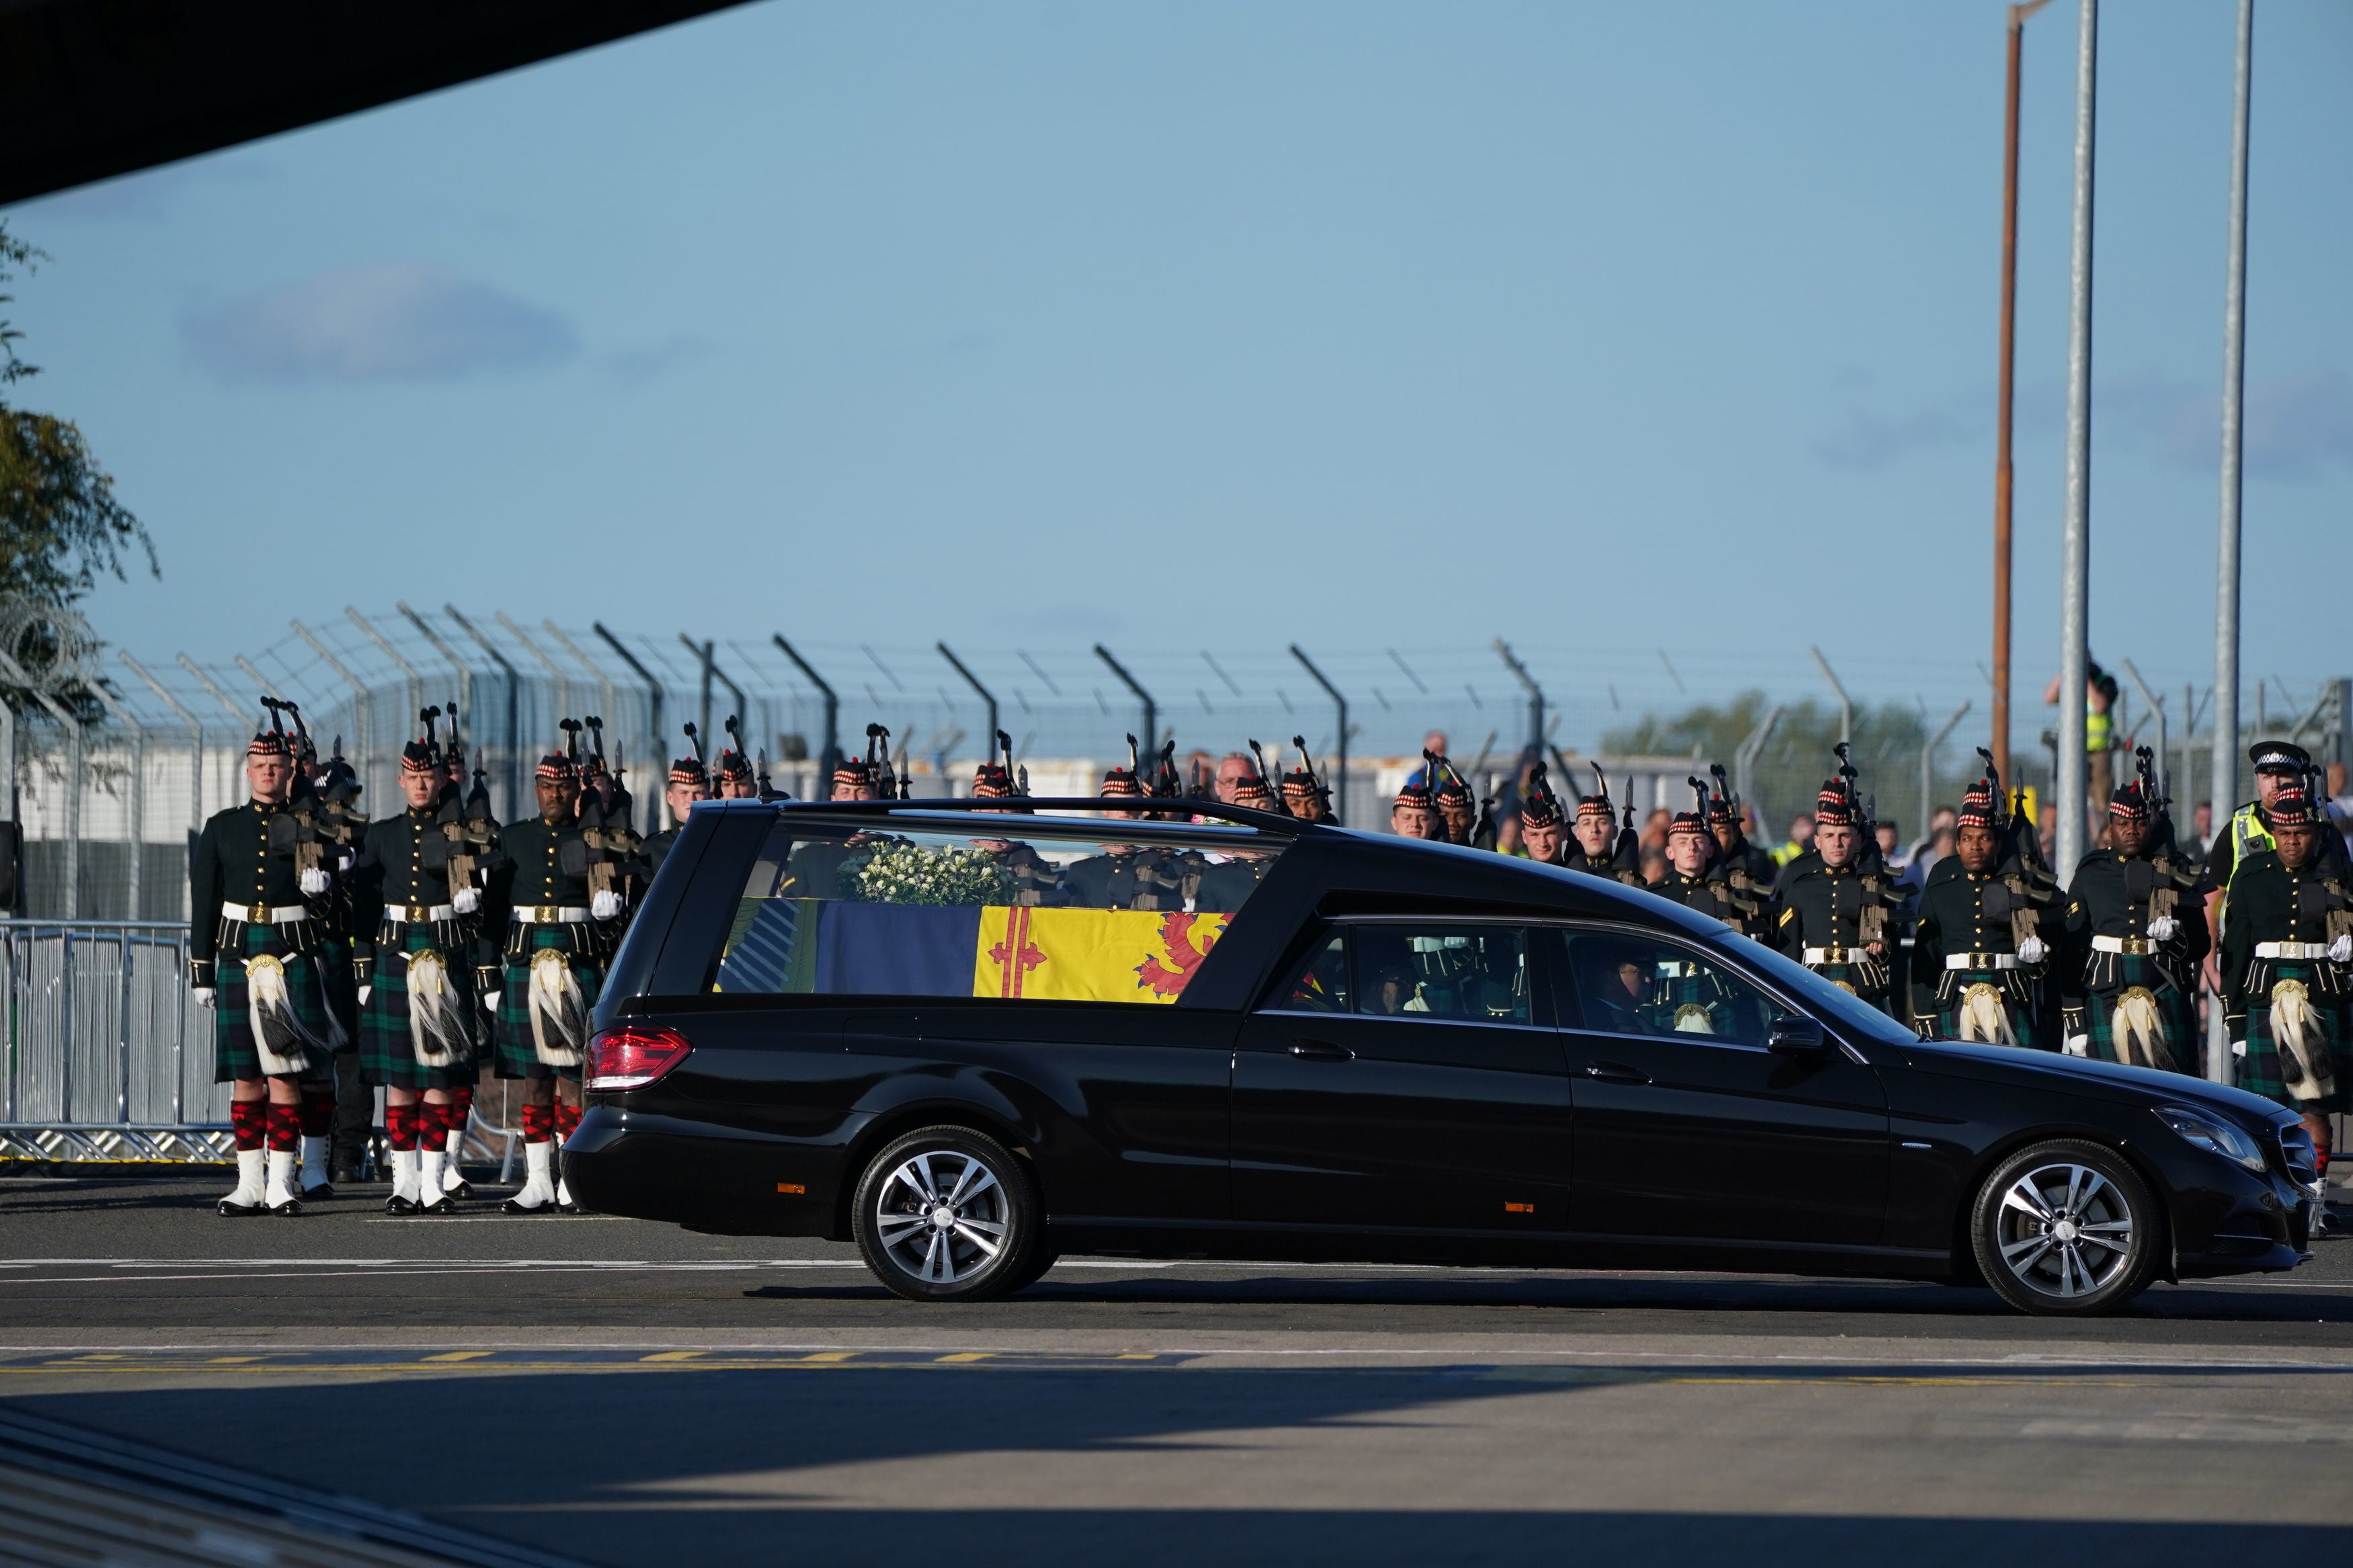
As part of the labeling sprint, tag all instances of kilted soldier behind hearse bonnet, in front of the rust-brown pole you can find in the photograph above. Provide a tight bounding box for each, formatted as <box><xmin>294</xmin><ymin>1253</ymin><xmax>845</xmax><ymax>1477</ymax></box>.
<box><xmin>1901</xmin><ymin>783</ymin><xmax>2050</xmax><ymax>1048</ymax></box>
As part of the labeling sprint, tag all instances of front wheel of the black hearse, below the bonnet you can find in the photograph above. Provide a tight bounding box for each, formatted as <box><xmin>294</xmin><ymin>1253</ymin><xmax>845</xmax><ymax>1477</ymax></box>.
<box><xmin>1970</xmin><ymin>1140</ymin><xmax>2165</xmax><ymax>1317</ymax></box>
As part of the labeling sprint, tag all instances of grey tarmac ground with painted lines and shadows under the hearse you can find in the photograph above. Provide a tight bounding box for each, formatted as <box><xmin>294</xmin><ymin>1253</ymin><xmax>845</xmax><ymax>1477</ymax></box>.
<box><xmin>0</xmin><ymin>1178</ymin><xmax>2353</xmax><ymax>1568</ymax></box>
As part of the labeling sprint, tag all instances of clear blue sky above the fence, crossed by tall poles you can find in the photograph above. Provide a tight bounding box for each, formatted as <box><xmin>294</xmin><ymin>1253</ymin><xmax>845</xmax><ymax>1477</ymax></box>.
<box><xmin>7</xmin><ymin>0</ymin><xmax>2353</xmax><ymax>745</ymax></box>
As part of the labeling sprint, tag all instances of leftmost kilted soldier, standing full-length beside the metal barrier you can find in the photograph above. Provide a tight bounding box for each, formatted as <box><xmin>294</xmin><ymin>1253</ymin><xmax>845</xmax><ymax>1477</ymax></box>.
<box><xmin>188</xmin><ymin>724</ymin><xmax>334</xmax><ymax>1218</ymax></box>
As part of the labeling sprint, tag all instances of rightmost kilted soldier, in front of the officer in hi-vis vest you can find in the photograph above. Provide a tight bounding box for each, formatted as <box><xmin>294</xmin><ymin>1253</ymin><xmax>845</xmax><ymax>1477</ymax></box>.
<box><xmin>2221</xmin><ymin>785</ymin><xmax>2353</xmax><ymax>1212</ymax></box>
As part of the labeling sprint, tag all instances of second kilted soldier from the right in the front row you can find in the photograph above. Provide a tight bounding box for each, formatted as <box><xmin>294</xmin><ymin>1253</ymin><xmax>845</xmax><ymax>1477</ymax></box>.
<box><xmin>2059</xmin><ymin>776</ymin><xmax>2207</xmax><ymax>1077</ymax></box>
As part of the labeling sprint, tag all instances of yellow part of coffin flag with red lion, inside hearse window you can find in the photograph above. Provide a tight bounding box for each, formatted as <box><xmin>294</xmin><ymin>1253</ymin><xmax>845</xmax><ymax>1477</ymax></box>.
<box><xmin>972</xmin><ymin>905</ymin><xmax>1226</xmax><ymax>1001</ymax></box>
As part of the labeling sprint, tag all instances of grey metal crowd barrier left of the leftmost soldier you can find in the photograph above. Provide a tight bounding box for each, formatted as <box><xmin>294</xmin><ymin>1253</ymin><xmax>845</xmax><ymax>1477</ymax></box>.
<box><xmin>0</xmin><ymin>919</ymin><xmax>235</xmax><ymax>1161</ymax></box>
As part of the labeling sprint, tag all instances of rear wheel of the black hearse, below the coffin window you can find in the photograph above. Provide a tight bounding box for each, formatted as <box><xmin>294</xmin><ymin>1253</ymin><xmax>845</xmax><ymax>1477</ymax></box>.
<box><xmin>852</xmin><ymin>1126</ymin><xmax>1045</xmax><ymax>1303</ymax></box>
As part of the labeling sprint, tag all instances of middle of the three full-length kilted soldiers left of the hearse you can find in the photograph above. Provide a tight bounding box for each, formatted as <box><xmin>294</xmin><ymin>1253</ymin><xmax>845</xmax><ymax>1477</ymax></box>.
<box><xmin>358</xmin><ymin>708</ymin><xmax>480</xmax><ymax>1215</ymax></box>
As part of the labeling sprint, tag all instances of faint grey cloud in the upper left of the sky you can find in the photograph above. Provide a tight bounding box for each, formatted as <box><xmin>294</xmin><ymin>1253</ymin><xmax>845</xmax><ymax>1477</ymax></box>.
<box><xmin>182</xmin><ymin>261</ymin><xmax>579</xmax><ymax>383</ymax></box>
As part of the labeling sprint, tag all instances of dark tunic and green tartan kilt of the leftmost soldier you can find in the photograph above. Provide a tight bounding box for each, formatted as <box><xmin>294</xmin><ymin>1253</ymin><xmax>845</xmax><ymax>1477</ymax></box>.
<box><xmin>188</xmin><ymin>802</ymin><xmax>337</xmax><ymax>1083</ymax></box>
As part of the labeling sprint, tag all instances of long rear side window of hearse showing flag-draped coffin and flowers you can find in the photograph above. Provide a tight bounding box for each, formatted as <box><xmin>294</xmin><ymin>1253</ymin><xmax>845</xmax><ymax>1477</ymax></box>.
<box><xmin>713</xmin><ymin>811</ymin><xmax>1280</xmax><ymax>1006</ymax></box>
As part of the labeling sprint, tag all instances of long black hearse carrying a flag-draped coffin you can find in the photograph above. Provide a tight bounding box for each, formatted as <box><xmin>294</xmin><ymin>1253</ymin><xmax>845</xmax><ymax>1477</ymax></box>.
<box><xmin>565</xmin><ymin>799</ymin><xmax>2313</xmax><ymax>1314</ymax></box>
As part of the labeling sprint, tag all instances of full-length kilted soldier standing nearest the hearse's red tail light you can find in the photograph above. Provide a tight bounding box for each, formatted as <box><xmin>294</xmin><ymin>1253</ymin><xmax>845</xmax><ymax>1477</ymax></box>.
<box><xmin>478</xmin><ymin>738</ymin><xmax>624</xmax><ymax>1213</ymax></box>
